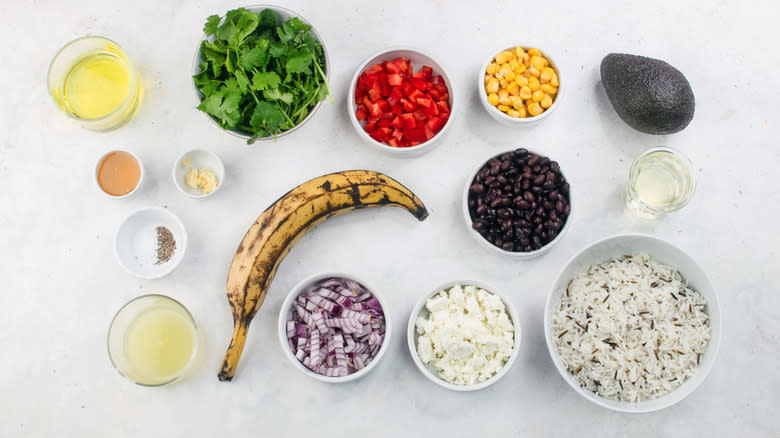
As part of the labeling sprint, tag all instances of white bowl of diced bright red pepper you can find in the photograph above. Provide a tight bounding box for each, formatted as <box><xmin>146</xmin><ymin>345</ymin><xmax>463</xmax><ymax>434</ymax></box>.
<box><xmin>347</xmin><ymin>47</ymin><xmax>454</xmax><ymax>156</ymax></box>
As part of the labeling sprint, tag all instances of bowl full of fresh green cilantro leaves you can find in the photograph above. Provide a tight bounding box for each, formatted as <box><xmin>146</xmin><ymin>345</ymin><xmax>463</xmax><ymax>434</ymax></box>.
<box><xmin>192</xmin><ymin>5</ymin><xmax>330</xmax><ymax>144</ymax></box>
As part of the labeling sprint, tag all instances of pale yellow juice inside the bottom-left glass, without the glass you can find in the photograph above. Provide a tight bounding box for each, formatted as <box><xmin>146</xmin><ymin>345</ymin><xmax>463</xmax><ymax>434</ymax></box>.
<box><xmin>124</xmin><ymin>305</ymin><xmax>197</xmax><ymax>385</ymax></box>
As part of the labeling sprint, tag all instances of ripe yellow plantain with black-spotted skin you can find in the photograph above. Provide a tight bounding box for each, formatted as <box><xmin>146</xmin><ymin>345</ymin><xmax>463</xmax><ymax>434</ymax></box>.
<box><xmin>218</xmin><ymin>170</ymin><xmax>428</xmax><ymax>381</ymax></box>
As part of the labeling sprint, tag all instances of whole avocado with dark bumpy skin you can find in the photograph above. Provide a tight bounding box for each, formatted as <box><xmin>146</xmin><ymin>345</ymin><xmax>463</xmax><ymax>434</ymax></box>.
<box><xmin>601</xmin><ymin>53</ymin><xmax>696</xmax><ymax>134</ymax></box>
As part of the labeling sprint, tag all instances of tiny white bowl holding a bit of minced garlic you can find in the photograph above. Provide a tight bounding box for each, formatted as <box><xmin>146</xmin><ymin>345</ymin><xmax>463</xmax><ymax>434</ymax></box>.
<box><xmin>173</xmin><ymin>149</ymin><xmax>225</xmax><ymax>198</ymax></box>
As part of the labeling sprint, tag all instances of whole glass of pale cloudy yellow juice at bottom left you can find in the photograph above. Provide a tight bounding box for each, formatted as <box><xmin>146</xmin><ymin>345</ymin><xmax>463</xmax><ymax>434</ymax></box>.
<box><xmin>108</xmin><ymin>294</ymin><xmax>198</xmax><ymax>386</ymax></box>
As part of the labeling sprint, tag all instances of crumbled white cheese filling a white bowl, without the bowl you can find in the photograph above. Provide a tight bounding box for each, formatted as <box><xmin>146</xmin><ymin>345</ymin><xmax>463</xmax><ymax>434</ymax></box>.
<box><xmin>415</xmin><ymin>285</ymin><xmax>514</xmax><ymax>385</ymax></box>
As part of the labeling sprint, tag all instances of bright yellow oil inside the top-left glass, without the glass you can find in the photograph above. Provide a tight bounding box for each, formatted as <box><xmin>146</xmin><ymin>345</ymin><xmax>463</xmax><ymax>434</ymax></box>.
<box><xmin>63</xmin><ymin>52</ymin><xmax>132</xmax><ymax>119</ymax></box>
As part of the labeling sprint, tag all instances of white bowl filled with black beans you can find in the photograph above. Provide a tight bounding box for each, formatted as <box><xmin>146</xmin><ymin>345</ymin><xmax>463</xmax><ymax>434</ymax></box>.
<box><xmin>463</xmin><ymin>148</ymin><xmax>572</xmax><ymax>259</ymax></box>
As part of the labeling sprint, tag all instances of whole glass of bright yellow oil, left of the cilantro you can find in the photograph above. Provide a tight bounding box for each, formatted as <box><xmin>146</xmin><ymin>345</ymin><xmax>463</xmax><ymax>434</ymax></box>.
<box><xmin>48</xmin><ymin>36</ymin><xmax>143</xmax><ymax>131</ymax></box>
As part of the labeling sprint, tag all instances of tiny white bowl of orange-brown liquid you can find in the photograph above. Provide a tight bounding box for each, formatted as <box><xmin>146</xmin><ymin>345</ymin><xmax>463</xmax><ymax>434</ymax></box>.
<box><xmin>95</xmin><ymin>150</ymin><xmax>144</xmax><ymax>199</ymax></box>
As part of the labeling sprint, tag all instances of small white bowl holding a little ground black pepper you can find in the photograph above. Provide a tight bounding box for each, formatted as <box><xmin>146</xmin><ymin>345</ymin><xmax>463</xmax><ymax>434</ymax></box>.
<box><xmin>114</xmin><ymin>207</ymin><xmax>187</xmax><ymax>279</ymax></box>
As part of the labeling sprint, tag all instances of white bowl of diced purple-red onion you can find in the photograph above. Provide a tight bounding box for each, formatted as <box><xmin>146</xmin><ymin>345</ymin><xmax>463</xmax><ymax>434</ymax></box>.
<box><xmin>279</xmin><ymin>273</ymin><xmax>392</xmax><ymax>383</ymax></box>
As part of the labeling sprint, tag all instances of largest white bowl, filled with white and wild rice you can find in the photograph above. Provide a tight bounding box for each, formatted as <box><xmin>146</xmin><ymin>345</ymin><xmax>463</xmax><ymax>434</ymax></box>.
<box><xmin>544</xmin><ymin>234</ymin><xmax>721</xmax><ymax>413</ymax></box>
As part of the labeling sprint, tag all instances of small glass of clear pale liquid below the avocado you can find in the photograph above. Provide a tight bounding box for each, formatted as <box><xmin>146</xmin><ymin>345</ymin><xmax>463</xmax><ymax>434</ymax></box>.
<box><xmin>626</xmin><ymin>147</ymin><xmax>696</xmax><ymax>216</ymax></box>
